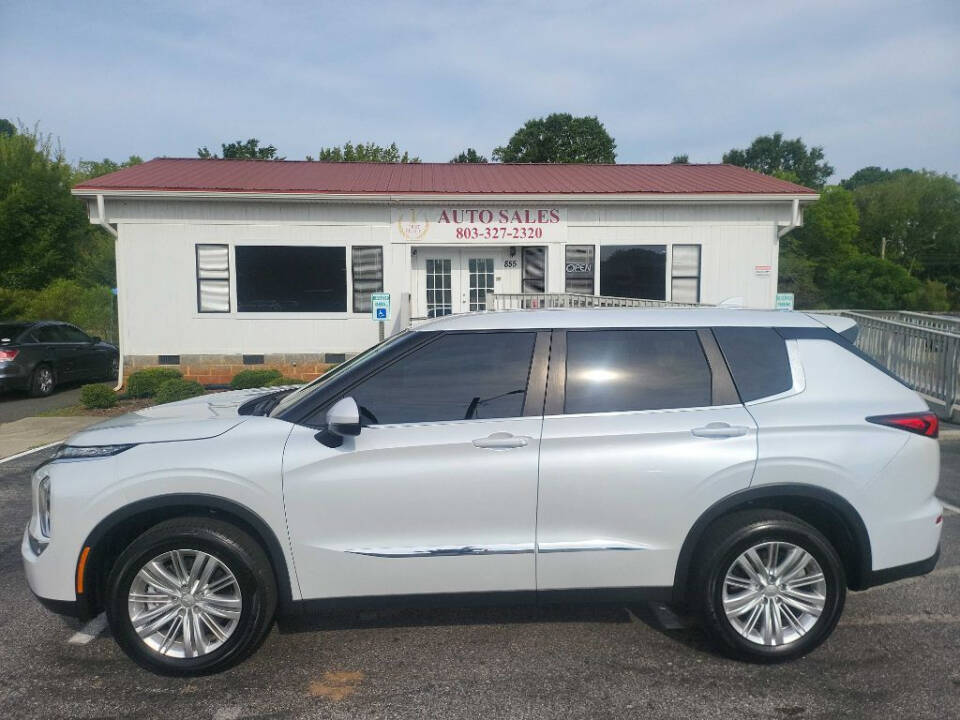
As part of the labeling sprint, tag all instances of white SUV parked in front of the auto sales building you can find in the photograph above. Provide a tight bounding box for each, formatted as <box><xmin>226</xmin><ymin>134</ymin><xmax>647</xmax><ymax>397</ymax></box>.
<box><xmin>22</xmin><ymin>309</ymin><xmax>942</xmax><ymax>675</ymax></box>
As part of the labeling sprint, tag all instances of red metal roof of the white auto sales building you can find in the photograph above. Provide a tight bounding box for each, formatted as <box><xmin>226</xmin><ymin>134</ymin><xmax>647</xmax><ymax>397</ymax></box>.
<box><xmin>75</xmin><ymin>158</ymin><xmax>816</xmax><ymax>195</ymax></box>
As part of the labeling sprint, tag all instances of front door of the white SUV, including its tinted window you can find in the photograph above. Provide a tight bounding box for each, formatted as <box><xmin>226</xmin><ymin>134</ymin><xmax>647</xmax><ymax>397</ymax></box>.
<box><xmin>283</xmin><ymin>332</ymin><xmax>549</xmax><ymax>599</ymax></box>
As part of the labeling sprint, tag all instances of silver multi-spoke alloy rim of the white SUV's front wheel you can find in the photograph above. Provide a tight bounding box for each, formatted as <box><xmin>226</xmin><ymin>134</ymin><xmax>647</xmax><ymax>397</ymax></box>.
<box><xmin>127</xmin><ymin>549</ymin><xmax>243</xmax><ymax>658</ymax></box>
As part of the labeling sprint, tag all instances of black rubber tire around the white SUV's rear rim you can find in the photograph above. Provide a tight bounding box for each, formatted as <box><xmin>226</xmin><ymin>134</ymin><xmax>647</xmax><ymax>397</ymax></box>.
<box><xmin>691</xmin><ymin>510</ymin><xmax>847</xmax><ymax>663</ymax></box>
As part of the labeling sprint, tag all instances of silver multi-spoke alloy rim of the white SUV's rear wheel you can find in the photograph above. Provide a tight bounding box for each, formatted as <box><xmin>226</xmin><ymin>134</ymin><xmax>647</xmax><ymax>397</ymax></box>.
<box><xmin>722</xmin><ymin>542</ymin><xmax>827</xmax><ymax>646</ymax></box>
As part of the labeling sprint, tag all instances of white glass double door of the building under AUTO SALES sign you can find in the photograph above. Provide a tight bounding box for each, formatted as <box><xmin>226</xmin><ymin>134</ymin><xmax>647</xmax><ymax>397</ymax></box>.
<box><xmin>419</xmin><ymin>248</ymin><xmax>501</xmax><ymax>318</ymax></box>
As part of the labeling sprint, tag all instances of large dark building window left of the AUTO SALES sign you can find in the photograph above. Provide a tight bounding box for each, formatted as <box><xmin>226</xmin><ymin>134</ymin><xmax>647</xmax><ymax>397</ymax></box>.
<box><xmin>236</xmin><ymin>245</ymin><xmax>347</xmax><ymax>312</ymax></box>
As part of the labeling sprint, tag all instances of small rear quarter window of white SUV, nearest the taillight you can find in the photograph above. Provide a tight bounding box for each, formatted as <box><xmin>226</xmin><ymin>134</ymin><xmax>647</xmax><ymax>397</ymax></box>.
<box><xmin>713</xmin><ymin>328</ymin><xmax>793</xmax><ymax>402</ymax></box>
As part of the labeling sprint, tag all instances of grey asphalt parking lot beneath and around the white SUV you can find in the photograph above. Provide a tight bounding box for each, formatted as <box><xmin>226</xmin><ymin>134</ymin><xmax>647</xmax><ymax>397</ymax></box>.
<box><xmin>0</xmin><ymin>440</ymin><xmax>960</xmax><ymax>720</ymax></box>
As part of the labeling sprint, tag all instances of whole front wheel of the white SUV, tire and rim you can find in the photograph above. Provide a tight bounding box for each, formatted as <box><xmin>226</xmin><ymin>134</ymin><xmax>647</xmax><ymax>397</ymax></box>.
<box><xmin>106</xmin><ymin>518</ymin><xmax>277</xmax><ymax>676</ymax></box>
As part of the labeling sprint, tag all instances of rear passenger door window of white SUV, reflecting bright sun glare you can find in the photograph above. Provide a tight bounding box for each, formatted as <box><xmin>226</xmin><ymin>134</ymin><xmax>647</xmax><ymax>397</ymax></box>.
<box><xmin>564</xmin><ymin>330</ymin><xmax>711</xmax><ymax>413</ymax></box>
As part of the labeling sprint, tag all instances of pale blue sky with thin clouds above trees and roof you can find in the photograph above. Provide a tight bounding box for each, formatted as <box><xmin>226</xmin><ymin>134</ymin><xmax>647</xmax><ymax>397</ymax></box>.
<box><xmin>0</xmin><ymin>0</ymin><xmax>960</xmax><ymax>182</ymax></box>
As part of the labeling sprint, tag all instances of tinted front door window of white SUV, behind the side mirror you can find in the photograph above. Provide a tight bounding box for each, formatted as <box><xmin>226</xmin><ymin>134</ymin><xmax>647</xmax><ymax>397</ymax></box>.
<box><xmin>349</xmin><ymin>333</ymin><xmax>536</xmax><ymax>424</ymax></box>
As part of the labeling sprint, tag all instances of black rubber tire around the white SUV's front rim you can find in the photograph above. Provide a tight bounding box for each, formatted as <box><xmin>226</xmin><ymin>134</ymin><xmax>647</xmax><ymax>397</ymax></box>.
<box><xmin>105</xmin><ymin>518</ymin><xmax>277</xmax><ymax>677</ymax></box>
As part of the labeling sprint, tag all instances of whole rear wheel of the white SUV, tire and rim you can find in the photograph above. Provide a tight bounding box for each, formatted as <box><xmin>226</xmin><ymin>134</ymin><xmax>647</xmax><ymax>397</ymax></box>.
<box><xmin>694</xmin><ymin>510</ymin><xmax>847</xmax><ymax>663</ymax></box>
